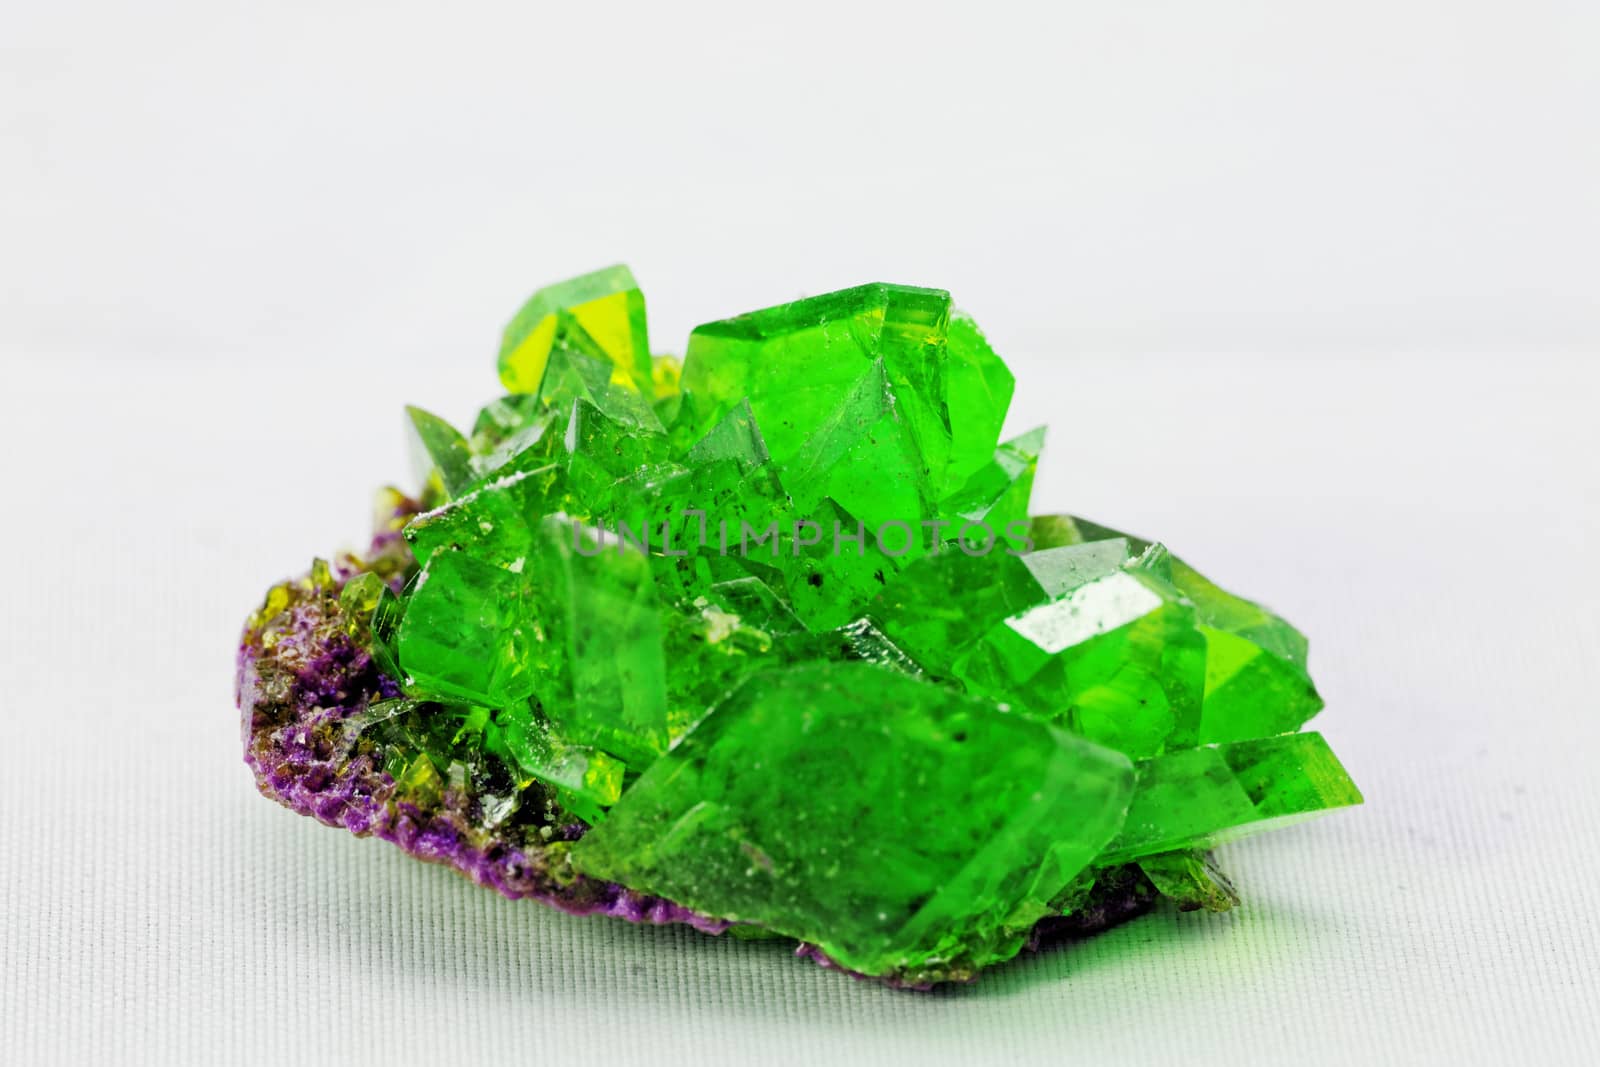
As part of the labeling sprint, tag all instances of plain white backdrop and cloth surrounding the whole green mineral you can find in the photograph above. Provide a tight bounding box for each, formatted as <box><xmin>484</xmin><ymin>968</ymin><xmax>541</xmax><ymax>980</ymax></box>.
<box><xmin>0</xmin><ymin>0</ymin><xmax>1600</xmax><ymax>1064</ymax></box>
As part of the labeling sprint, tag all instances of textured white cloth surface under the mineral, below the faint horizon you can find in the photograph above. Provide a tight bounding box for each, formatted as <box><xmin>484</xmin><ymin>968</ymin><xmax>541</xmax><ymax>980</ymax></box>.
<box><xmin>0</xmin><ymin>357</ymin><xmax>1600</xmax><ymax>1064</ymax></box>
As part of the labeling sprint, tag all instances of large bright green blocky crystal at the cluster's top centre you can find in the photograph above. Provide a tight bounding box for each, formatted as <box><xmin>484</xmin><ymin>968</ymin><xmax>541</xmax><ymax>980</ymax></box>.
<box><xmin>683</xmin><ymin>285</ymin><xmax>1010</xmax><ymax>550</ymax></box>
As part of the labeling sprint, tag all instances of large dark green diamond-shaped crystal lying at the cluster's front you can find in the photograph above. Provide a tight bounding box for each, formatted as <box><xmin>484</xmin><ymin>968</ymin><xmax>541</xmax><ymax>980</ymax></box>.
<box><xmin>573</xmin><ymin>664</ymin><xmax>1133</xmax><ymax>976</ymax></box>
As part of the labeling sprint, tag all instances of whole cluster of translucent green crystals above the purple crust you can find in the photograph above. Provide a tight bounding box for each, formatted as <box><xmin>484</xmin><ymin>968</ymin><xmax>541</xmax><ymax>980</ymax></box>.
<box><xmin>363</xmin><ymin>267</ymin><xmax>1360</xmax><ymax>981</ymax></box>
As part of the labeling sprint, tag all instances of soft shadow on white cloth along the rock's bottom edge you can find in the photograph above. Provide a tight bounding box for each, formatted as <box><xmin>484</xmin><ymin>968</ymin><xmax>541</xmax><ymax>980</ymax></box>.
<box><xmin>248</xmin><ymin>798</ymin><xmax>1350</xmax><ymax>1024</ymax></box>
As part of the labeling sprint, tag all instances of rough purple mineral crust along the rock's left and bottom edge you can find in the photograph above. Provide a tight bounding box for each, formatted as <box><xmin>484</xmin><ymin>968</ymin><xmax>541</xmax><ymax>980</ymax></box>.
<box><xmin>235</xmin><ymin>494</ymin><xmax>1157</xmax><ymax>989</ymax></box>
